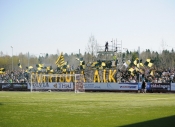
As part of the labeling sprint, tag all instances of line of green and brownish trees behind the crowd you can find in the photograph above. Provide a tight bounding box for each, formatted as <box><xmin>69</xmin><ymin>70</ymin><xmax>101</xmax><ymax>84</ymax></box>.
<box><xmin>0</xmin><ymin>49</ymin><xmax>175</xmax><ymax>70</ymax></box>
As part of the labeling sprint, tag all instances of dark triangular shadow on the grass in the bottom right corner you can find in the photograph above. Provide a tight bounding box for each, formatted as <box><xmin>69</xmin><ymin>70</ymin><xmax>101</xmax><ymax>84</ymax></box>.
<box><xmin>120</xmin><ymin>115</ymin><xmax>175</xmax><ymax>127</ymax></box>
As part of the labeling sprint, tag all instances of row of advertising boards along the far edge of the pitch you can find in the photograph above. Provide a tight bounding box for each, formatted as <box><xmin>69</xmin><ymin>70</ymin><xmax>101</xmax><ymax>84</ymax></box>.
<box><xmin>0</xmin><ymin>82</ymin><xmax>175</xmax><ymax>93</ymax></box>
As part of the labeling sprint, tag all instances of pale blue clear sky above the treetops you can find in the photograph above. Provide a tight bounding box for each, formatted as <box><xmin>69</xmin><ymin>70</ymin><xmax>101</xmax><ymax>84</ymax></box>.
<box><xmin>0</xmin><ymin>0</ymin><xmax>175</xmax><ymax>55</ymax></box>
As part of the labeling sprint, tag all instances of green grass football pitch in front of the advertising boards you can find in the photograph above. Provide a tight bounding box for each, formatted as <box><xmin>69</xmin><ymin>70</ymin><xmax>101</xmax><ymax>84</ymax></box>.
<box><xmin>0</xmin><ymin>91</ymin><xmax>175</xmax><ymax>127</ymax></box>
